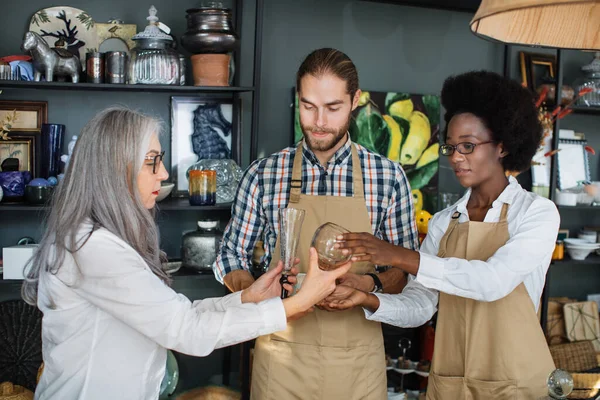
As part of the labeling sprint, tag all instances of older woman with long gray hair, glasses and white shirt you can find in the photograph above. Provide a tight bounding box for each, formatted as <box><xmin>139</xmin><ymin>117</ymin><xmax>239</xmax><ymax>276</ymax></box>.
<box><xmin>23</xmin><ymin>108</ymin><xmax>350</xmax><ymax>400</ymax></box>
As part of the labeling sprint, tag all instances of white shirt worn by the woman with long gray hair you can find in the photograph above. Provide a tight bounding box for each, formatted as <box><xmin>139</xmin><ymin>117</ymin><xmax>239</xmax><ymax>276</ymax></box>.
<box><xmin>35</xmin><ymin>225</ymin><xmax>286</xmax><ymax>400</ymax></box>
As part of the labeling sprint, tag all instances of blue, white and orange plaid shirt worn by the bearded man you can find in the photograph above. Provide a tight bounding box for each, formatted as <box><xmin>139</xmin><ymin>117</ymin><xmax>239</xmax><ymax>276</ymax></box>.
<box><xmin>213</xmin><ymin>140</ymin><xmax>418</xmax><ymax>282</ymax></box>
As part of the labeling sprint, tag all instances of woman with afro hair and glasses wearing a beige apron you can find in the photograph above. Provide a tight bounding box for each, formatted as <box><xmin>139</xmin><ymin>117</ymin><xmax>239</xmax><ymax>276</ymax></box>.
<box><xmin>322</xmin><ymin>71</ymin><xmax>560</xmax><ymax>400</ymax></box>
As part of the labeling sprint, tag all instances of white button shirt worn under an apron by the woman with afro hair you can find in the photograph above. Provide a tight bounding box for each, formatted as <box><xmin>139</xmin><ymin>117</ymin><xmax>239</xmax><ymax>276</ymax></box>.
<box><xmin>365</xmin><ymin>177</ymin><xmax>560</xmax><ymax>327</ymax></box>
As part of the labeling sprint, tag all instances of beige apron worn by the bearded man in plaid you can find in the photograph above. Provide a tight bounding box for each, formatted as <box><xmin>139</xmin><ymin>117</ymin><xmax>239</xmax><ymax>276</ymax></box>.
<box><xmin>252</xmin><ymin>143</ymin><xmax>387</xmax><ymax>400</ymax></box>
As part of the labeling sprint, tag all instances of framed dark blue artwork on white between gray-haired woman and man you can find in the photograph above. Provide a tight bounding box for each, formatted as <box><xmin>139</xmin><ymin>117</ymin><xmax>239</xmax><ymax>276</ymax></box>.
<box><xmin>171</xmin><ymin>96</ymin><xmax>241</xmax><ymax>197</ymax></box>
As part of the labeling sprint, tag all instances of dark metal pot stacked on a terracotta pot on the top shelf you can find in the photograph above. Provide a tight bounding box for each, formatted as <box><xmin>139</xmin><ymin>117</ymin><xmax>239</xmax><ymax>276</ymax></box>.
<box><xmin>181</xmin><ymin>2</ymin><xmax>238</xmax><ymax>86</ymax></box>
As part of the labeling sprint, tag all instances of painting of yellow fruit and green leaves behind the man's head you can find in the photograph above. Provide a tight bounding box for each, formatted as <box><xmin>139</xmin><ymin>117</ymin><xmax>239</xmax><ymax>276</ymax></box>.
<box><xmin>292</xmin><ymin>88</ymin><xmax>440</xmax><ymax>214</ymax></box>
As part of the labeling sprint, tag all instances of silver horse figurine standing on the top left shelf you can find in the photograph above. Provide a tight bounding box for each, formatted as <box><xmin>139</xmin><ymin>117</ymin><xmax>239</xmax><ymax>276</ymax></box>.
<box><xmin>22</xmin><ymin>32</ymin><xmax>81</xmax><ymax>83</ymax></box>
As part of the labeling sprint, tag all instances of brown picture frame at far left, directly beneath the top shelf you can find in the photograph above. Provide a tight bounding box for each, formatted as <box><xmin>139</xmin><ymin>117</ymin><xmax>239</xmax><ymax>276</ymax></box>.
<box><xmin>0</xmin><ymin>100</ymin><xmax>48</xmax><ymax>133</ymax></box>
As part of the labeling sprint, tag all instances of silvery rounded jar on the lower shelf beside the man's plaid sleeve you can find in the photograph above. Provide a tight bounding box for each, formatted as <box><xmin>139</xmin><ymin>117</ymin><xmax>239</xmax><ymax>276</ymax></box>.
<box><xmin>181</xmin><ymin>220</ymin><xmax>223</xmax><ymax>272</ymax></box>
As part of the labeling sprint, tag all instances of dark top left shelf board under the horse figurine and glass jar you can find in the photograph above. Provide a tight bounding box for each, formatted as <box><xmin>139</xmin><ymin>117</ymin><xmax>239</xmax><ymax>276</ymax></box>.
<box><xmin>0</xmin><ymin>81</ymin><xmax>254</xmax><ymax>94</ymax></box>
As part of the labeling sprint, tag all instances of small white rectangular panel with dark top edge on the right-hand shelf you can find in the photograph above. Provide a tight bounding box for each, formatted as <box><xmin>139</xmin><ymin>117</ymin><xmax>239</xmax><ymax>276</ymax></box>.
<box><xmin>556</xmin><ymin>139</ymin><xmax>590</xmax><ymax>190</ymax></box>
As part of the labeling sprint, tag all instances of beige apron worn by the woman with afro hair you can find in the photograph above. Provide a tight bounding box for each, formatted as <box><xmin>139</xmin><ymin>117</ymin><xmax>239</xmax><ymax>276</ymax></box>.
<box><xmin>427</xmin><ymin>204</ymin><xmax>554</xmax><ymax>400</ymax></box>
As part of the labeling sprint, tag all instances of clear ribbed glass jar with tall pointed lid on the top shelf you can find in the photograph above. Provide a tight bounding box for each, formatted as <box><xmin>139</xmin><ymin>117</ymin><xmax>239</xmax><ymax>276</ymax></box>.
<box><xmin>128</xmin><ymin>6</ymin><xmax>180</xmax><ymax>85</ymax></box>
